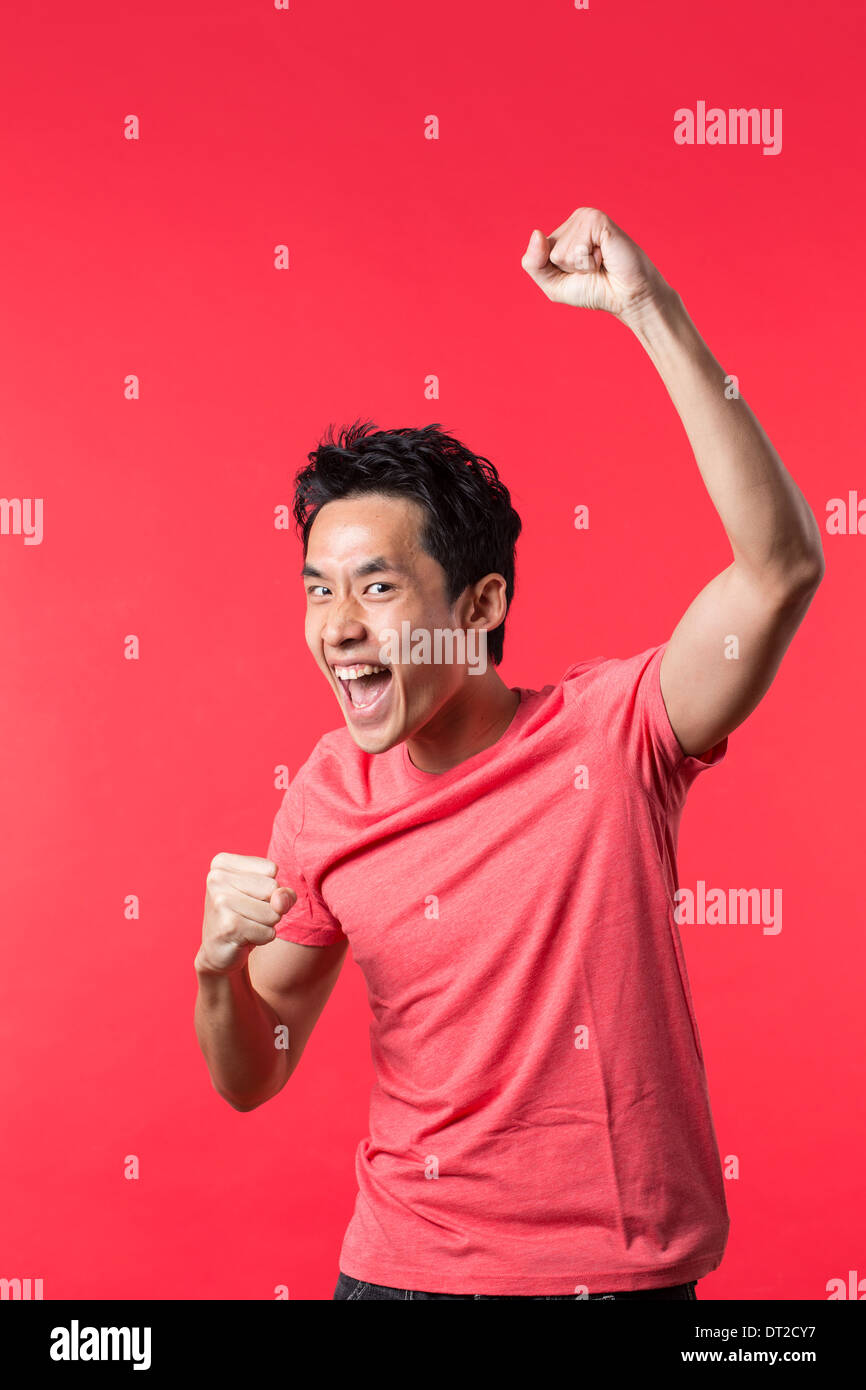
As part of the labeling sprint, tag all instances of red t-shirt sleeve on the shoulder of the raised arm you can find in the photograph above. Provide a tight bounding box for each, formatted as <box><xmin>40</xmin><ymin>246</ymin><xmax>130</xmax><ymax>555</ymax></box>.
<box><xmin>564</xmin><ymin>642</ymin><xmax>728</xmax><ymax>802</ymax></box>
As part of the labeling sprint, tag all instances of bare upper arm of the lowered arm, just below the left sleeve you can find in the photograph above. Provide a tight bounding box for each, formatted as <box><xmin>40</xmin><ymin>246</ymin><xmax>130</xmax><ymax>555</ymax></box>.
<box><xmin>249</xmin><ymin>937</ymin><xmax>349</xmax><ymax>1084</ymax></box>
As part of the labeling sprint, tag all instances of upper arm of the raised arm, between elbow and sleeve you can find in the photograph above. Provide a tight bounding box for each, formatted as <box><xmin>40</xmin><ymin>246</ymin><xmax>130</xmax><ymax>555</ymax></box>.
<box><xmin>659</xmin><ymin>562</ymin><xmax>820</xmax><ymax>758</ymax></box>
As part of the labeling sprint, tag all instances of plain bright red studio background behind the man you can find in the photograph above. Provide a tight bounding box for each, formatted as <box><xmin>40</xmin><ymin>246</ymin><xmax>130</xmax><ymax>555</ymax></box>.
<box><xmin>0</xmin><ymin>0</ymin><xmax>866</xmax><ymax>1300</ymax></box>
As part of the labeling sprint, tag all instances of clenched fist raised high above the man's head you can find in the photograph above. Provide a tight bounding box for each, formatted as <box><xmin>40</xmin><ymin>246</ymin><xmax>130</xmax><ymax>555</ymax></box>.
<box><xmin>520</xmin><ymin>207</ymin><xmax>671</xmax><ymax>322</ymax></box>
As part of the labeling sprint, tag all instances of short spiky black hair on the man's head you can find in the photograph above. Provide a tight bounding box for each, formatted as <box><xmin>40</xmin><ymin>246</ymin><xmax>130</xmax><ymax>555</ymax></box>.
<box><xmin>293</xmin><ymin>420</ymin><xmax>521</xmax><ymax>666</ymax></box>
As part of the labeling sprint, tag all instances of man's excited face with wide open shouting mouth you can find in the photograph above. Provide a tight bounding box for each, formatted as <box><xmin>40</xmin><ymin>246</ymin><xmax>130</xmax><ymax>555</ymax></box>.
<box><xmin>303</xmin><ymin>493</ymin><xmax>466</xmax><ymax>753</ymax></box>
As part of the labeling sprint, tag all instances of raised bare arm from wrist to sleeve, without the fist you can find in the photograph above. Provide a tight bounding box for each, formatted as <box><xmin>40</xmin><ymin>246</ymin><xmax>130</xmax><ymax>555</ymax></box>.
<box><xmin>630</xmin><ymin>286</ymin><xmax>824</xmax><ymax>756</ymax></box>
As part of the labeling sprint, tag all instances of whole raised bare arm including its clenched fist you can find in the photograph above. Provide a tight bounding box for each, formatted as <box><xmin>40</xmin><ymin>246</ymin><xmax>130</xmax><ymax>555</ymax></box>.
<box><xmin>523</xmin><ymin>207</ymin><xmax>824</xmax><ymax>756</ymax></box>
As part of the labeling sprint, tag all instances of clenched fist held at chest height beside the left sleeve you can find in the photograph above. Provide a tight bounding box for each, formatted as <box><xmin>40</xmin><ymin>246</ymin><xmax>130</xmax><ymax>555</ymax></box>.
<box><xmin>196</xmin><ymin>853</ymin><xmax>297</xmax><ymax>974</ymax></box>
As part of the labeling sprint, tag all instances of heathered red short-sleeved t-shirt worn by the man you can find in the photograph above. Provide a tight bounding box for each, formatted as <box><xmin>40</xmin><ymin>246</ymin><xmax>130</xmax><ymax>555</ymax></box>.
<box><xmin>268</xmin><ymin>644</ymin><xmax>728</xmax><ymax>1294</ymax></box>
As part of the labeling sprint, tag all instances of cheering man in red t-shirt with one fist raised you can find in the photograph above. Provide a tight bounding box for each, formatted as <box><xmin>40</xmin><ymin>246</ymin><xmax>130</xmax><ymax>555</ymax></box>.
<box><xmin>196</xmin><ymin>207</ymin><xmax>824</xmax><ymax>1300</ymax></box>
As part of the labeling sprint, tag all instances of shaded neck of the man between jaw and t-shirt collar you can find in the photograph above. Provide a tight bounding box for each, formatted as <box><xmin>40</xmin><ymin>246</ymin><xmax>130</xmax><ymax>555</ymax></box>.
<box><xmin>406</xmin><ymin>666</ymin><xmax>520</xmax><ymax>773</ymax></box>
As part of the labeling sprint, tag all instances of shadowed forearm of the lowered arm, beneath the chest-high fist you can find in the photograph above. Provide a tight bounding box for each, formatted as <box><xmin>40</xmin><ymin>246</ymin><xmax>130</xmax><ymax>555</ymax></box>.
<box><xmin>195</xmin><ymin>958</ymin><xmax>289</xmax><ymax>1111</ymax></box>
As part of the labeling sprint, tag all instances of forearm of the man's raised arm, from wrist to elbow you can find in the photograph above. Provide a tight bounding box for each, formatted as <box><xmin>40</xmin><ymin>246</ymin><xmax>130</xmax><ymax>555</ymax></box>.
<box><xmin>630</xmin><ymin>289</ymin><xmax>823</xmax><ymax>584</ymax></box>
